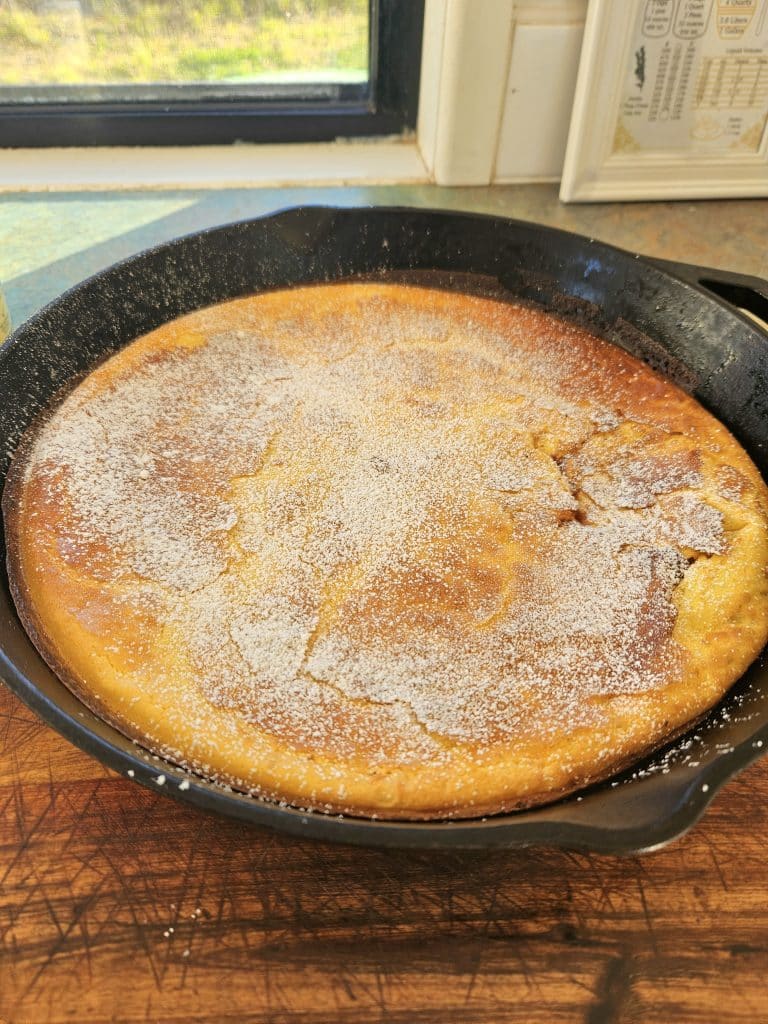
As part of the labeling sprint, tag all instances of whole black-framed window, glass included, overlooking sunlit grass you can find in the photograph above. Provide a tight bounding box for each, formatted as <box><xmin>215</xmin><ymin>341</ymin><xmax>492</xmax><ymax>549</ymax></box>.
<box><xmin>0</xmin><ymin>0</ymin><xmax>424</xmax><ymax>146</ymax></box>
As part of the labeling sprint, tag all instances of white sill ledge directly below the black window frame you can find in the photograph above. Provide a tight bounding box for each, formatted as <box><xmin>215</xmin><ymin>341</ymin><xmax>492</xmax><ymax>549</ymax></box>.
<box><xmin>0</xmin><ymin>140</ymin><xmax>430</xmax><ymax>191</ymax></box>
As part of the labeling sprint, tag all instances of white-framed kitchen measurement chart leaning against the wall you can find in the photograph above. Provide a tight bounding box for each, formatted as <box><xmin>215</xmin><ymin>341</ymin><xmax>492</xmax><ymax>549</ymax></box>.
<box><xmin>560</xmin><ymin>0</ymin><xmax>768</xmax><ymax>203</ymax></box>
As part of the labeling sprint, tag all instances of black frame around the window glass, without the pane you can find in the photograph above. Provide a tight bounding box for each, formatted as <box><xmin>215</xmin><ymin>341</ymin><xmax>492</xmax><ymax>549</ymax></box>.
<box><xmin>0</xmin><ymin>0</ymin><xmax>424</xmax><ymax>147</ymax></box>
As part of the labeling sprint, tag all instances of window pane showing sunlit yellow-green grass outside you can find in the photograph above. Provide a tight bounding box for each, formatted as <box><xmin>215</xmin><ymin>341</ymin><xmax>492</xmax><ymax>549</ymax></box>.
<box><xmin>0</xmin><ymin>0</ymin><xmax>372</xmax><ymax>103</ymax></box>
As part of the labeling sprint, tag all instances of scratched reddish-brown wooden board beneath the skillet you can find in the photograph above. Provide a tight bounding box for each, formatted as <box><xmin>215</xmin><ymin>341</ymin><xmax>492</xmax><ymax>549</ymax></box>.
<box><xmin>0</xmin><ymin>686</ymin><xmax>768</xmax><ymax>1024</ymax></box>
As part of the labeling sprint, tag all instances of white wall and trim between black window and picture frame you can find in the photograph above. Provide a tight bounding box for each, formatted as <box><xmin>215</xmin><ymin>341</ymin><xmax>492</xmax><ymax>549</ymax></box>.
<box><xmin>418</xmin><ymin>0</ymin><xmax>587</xmax><ymax>185</ymax></box>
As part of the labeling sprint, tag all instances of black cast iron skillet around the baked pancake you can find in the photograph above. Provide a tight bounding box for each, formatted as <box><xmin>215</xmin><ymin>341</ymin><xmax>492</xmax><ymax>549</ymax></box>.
<box><xmin>0</xmin><ymin>207</ymin><xmax>768</xmax><ymax>853</ymax></box>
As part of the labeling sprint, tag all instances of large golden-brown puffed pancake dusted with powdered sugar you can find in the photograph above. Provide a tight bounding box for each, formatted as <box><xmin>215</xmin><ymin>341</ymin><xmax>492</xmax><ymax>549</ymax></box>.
<box><xmin>4</xmin><ymin>283</ymin><xmax>768</xmax><ymax>818</ymax></box>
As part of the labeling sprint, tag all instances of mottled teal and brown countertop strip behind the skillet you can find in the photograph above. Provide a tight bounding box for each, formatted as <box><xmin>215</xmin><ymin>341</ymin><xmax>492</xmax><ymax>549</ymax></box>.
<box><xmin>0</xmin><ymin>184</ymin><xmax>768</xmax><ymax>326</ymax></box>
